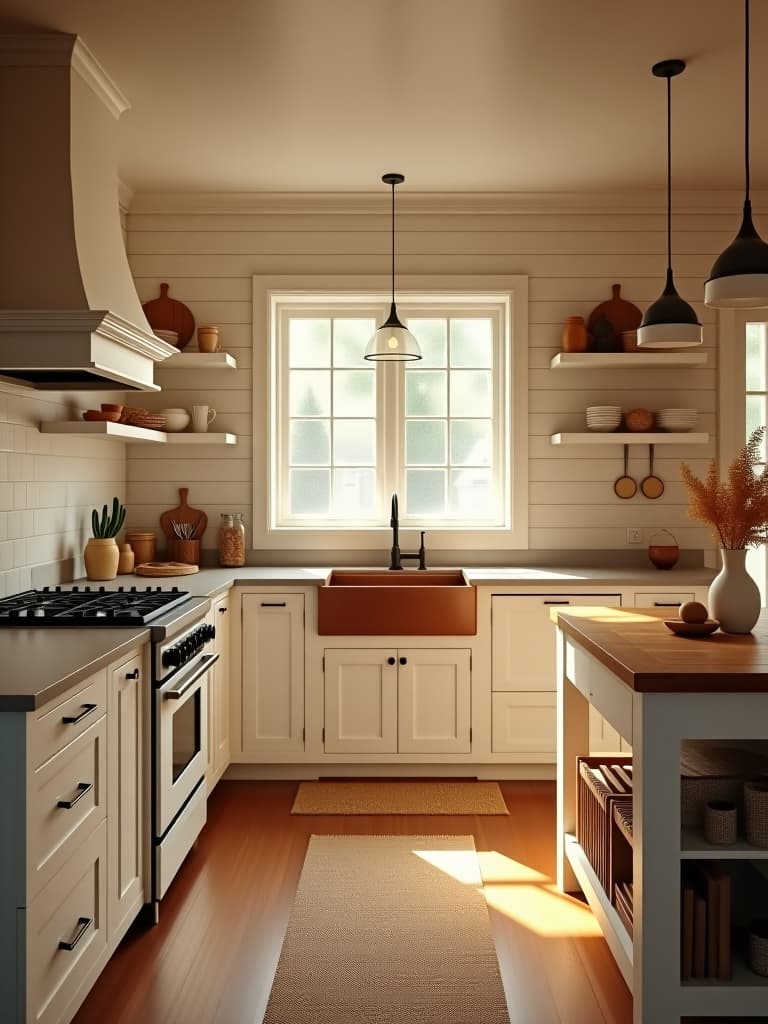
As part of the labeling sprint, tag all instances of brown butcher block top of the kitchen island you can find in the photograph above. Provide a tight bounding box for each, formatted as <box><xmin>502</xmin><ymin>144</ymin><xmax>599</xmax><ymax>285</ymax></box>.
<box><xmin>550</xmin><ymin>606</ymin><xmax>768</xmax><ymax>693</ymax></box>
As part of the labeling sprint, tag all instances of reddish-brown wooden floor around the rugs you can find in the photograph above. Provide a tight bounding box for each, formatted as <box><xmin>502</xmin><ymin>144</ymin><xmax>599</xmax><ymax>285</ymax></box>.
<box><xmin>75</xmin><ymin>782</ymin><xmax>757</xmax><ymax>1024</ymax></box>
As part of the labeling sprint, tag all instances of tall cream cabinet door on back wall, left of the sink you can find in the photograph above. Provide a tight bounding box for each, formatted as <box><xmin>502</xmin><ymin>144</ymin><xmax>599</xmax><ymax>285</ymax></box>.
<box><xmin>242</xmin><ymin>594</ymin><xmax>304</xmax><ymax>754</ymax></box>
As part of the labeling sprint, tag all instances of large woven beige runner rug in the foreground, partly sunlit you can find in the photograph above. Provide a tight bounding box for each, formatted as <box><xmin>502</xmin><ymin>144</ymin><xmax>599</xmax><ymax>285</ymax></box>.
<box><xmin>264</xmin><ymin>836</ymin><xmax>509</xmax><ymax>1024</ymax></box>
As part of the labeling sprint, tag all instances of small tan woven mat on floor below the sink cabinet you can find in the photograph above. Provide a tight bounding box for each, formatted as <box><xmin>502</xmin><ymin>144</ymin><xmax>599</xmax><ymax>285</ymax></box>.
<box><xmin>291</xmin><ymin>782</ymin><xmax>509</xmax><ymax>814</ymax></box>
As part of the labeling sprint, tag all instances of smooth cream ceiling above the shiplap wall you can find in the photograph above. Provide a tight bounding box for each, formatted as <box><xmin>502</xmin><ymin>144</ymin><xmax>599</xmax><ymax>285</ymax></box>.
<box><xmin>0</xmin><ymin>0</ymin><xmax>768</xmax><ymax>191</ymax></box>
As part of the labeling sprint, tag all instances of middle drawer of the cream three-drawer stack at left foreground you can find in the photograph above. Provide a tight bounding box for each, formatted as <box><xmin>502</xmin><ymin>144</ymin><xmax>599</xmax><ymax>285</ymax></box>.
<box><xmin>28</xmin><ymin>715</ymin><xmax>106</xmax><ymax>894</ymax></box>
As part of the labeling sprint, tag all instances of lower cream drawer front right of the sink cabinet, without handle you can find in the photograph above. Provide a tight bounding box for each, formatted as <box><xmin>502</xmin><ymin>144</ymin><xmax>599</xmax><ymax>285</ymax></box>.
<box><xmin>492</xmin><ymin>693</ymin><xmax>557</xmax><ymax>762</ymax></box>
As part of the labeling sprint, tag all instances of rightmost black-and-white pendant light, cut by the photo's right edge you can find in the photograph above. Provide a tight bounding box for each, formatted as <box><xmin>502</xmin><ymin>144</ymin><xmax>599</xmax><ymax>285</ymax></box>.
<box><xmin>705</xmin><ymin>0</ymin><xmax>768</xmax><ymax>309</ymax></box>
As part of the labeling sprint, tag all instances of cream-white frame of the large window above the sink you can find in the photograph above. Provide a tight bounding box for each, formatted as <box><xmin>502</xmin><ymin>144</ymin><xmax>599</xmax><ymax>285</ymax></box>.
<box><xmin>253</xmin><ymin>274</ymin><xmax>528</xmax><ymax>552</ymax></box>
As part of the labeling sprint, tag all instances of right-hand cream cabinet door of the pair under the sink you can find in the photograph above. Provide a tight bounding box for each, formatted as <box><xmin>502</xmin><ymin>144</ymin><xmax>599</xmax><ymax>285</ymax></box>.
<box><xmin>397</xmin><ymin>648</ymin><xmax>472</xmax><ymax>754</ymax></box>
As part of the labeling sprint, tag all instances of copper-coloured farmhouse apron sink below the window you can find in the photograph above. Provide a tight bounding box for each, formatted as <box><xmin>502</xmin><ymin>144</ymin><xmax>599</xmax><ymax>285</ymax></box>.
<box><xmin>317</xmin><ymin>569</ymin><xmax>477</xmax><ymax>636</ymax></box>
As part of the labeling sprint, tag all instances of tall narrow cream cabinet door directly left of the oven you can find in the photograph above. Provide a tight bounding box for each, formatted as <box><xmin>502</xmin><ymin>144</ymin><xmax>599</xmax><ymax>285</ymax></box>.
<box><xmin>106</xmin><ymin>652</ymin><xmax>144</xmax><ymax>941</ymax></box>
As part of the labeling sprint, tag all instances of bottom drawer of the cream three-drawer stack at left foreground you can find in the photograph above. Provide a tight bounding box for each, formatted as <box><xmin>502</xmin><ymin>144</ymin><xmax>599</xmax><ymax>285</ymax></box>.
<box><xmin>27</xmin><ymin>821</ymin><xmax>106</xmax><ymax>1024</ymax></box>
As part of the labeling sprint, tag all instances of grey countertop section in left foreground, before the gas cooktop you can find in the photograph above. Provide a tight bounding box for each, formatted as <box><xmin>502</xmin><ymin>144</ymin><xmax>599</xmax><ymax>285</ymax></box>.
<box><xmin>0</xmin><ymin>627</ymin><xmax>150</xmax><ymax>712</ymax></box>
